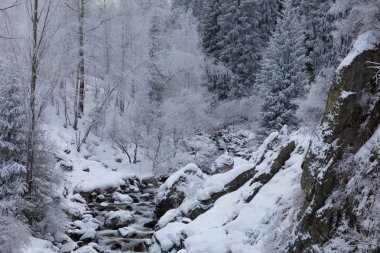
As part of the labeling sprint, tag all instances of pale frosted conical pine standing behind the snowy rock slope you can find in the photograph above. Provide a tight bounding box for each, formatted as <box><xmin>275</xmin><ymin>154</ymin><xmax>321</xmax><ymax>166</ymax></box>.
<box><xmin>257</xmin><ymin>0</ymin><xmax>308</xmax><ymax>133</ymax></box>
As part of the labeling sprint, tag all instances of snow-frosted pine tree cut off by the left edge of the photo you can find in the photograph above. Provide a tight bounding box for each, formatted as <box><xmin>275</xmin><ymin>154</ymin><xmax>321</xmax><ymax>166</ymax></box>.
<box><xmin>0</xmin><ymin>64</ymin><xmax>27</xmax><ymax>199</ymax></box>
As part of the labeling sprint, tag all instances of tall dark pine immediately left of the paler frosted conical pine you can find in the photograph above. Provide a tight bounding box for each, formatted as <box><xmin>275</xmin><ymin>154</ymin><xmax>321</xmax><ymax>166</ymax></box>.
<box><xmin>219</xmin><ymin>0</ymin><xmax>261</xmax><ymax>97</ymax></box>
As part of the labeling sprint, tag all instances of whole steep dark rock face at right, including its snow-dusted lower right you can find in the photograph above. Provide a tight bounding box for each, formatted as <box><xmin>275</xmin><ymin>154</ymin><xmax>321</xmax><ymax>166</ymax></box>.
<box><xmin>289</xmin><ymin>34</ymin><xmax>380</xmax><ymax>252</ymax></box>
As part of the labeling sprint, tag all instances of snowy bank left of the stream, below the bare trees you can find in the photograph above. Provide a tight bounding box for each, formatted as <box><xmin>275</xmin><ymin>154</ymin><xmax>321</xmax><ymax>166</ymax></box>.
<box><xmin>44</xmin><ymin>108</ymin><xmax>152</xmax><ymax>192</ymax></box>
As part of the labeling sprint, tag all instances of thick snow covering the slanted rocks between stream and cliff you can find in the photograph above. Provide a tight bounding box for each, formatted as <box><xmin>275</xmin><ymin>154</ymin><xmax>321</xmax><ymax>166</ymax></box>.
<box><xmin>153</xmin><ymin>131</ymin><xmax>310</xmax><ymax>253</ymax></box>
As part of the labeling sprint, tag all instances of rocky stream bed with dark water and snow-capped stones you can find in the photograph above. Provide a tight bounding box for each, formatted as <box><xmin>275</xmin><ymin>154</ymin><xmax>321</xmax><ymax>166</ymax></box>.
<box><xmin>60</xmin><ymin>178</ymin><xmax>159</xmax><ymax>253</ymax></box>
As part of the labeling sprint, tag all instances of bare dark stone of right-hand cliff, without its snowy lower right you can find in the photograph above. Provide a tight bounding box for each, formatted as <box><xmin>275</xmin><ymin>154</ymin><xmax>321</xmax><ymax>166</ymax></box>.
<box><xmin>289</xmin><ymin>40</ymin><xmax>380</xmax><ymax>252</ymax></box>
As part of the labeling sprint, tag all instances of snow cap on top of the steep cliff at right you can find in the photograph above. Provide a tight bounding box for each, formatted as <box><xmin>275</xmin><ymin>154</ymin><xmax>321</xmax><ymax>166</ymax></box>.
<box><xmin>337</xmin><ymin>30</ymin><xmax>380</xmax><ymax>73</ymax></box>
